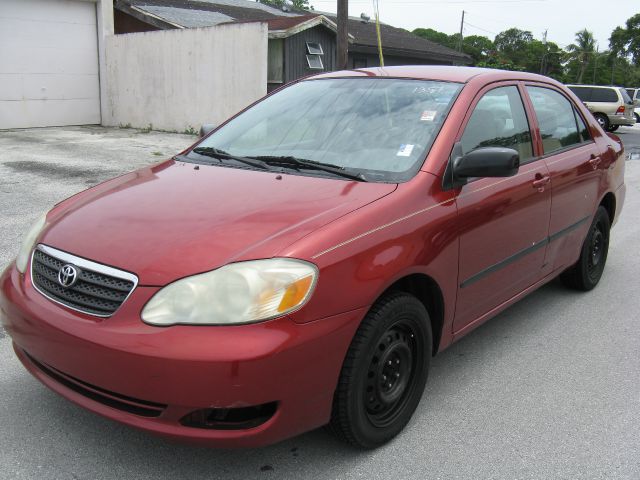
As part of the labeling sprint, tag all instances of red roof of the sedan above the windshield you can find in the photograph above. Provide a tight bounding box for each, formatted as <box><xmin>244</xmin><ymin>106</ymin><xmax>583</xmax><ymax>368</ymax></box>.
<box><xmin>308</xmin><ymin>65</ymin><xmax>559</xmax><ymax>85</ymax></box>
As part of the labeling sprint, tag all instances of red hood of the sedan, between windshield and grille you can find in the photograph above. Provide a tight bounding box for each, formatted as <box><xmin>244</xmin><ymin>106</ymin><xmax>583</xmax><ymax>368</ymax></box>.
<box><xmin>39</xmin><ymin>161</ymin><xmax>397</xmax><ymax>286</ymax></box>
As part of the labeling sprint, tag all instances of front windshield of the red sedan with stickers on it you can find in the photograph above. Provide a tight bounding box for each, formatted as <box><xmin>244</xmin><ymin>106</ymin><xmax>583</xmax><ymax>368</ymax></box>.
<box><xmin>189</xmin><ymin>78</ymin><xmax>462</xmax><ymax>182</ymax></box>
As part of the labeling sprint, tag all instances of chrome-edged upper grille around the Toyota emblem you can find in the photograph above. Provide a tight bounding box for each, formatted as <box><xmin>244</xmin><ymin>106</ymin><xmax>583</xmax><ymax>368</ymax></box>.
<box><xmin>31</xmin><ymin>245</ymin><xmax>137</xmax><ymax>317</ymax></box>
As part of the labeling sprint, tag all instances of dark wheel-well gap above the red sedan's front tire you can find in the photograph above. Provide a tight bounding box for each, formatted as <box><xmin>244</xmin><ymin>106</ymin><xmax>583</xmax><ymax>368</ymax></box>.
<box><xmin>376</xmin><ymin>273</ymin><xmax>444</xmax><ymax>355</ymax></box>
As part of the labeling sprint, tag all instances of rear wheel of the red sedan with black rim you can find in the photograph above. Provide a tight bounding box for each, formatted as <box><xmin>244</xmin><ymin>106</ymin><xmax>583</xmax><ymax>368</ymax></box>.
<box><xmin>560</xmin><ymin>206</ymin><xmax>611</xmax><ymax>292</ymax></box>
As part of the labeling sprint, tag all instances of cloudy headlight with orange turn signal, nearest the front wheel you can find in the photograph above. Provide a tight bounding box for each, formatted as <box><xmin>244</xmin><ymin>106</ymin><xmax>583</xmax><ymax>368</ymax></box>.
<box><xmin>142</xmin><ymin>258</ymin><xmax>318</xmax><ymax>326</ymax></box>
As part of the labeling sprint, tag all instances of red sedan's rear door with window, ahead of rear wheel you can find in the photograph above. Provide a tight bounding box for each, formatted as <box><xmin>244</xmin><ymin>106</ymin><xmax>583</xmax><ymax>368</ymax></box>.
<box><xmin>526</xmin><ymin>84</ymin><xmax>603</xmax><ymax>271</ymax></box>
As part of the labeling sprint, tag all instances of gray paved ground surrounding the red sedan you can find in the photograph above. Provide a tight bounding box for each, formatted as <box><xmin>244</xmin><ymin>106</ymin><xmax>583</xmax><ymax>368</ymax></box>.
<box><xmin>0</xmin><ymin>128</ymin><xmax>640</xmax><ymax>480</ymax></box>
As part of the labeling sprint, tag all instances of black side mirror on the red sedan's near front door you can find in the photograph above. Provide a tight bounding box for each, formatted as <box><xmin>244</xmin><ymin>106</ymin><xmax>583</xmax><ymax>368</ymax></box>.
<box><xmin>452</xmin><ymin>147</ymin><xmax>520</xmax><ymax>184</ymax></box>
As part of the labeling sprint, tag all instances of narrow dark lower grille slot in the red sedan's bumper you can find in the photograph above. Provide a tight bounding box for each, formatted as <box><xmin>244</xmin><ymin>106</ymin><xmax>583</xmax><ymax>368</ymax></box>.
<box><xmin>23</xmin><ymin>350</ymin><xmax>167</xmax><ymax>417</ymax></box>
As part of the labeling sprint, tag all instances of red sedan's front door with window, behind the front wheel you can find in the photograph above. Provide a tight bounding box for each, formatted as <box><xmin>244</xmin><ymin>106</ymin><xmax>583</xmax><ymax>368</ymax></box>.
<box><xmin>454</xmin><ymin>83</ymin><xmax>551</xmax><ymax>334</ymax></box>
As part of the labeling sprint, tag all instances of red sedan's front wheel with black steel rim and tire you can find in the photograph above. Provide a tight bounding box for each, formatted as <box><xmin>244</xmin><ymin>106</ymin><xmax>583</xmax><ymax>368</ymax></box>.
<box><xmin>328</xmin><ymin>292</ymin><xmax>433</xmax><ymax>449</ymax></box>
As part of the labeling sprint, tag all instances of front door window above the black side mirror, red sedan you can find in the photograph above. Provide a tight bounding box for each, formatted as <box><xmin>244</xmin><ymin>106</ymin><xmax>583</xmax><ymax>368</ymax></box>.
<box><xmin>460</xmin><ymin>86</ymin><xmax>533</xmax><ymax>163</ymax></box>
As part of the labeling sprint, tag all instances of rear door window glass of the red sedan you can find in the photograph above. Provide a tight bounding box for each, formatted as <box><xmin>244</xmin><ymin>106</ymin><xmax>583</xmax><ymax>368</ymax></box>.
<box><xmin>527</xmin><ymin>86</ymin><xmax>586</xmax><ymax>155</ymax></box>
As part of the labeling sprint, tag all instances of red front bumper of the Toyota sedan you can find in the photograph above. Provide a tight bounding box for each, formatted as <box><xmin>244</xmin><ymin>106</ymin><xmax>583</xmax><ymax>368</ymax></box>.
<box><xmin>0</xmin><ymin>266</ymin><xmax>365</xmax><ymax>447</ymax></box>
